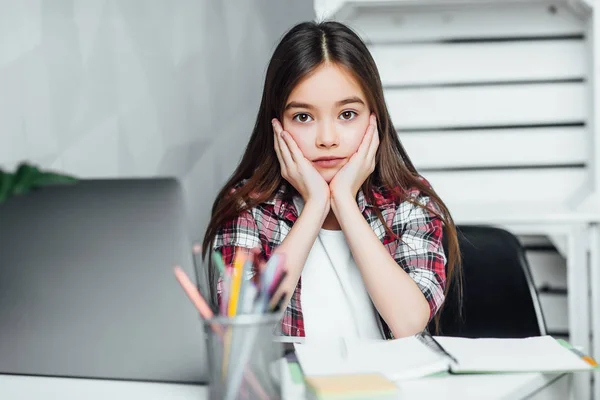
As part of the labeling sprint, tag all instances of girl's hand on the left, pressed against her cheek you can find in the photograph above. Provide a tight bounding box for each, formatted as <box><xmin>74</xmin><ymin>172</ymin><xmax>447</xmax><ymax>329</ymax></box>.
<box><xmin>272</xmin><ymin>118</ymin><xmax>330</xmax><ymax>208</ymax></box>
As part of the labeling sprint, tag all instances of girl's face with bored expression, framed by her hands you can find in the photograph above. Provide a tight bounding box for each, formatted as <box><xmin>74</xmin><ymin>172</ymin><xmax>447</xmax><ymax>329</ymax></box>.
<box><xmin>281</xmin><ymin>63</ymin><xmax>370</xmax><ymax>183</ymax></box>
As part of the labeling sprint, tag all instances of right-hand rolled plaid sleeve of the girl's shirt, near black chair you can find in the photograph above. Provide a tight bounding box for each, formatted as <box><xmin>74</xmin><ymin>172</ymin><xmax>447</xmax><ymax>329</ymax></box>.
<box><xmin>392</xmin><ymin>195</ymin><xmax>446</xmax><ymax>320</ymax></box>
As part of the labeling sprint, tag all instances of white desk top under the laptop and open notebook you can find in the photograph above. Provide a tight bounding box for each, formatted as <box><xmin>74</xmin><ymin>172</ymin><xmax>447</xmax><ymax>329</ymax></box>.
<box><xmin>0</xmin><ymin>374</ymin><xmax>571</xmax><ymax>400</ymax></box>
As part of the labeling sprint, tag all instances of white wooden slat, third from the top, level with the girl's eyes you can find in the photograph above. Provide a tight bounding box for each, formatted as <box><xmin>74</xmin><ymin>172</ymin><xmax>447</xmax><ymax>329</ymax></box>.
<box><xmin>385</xmin><ymin>83</ymin><xmax>586</xmax><ymax>129</ymax></box>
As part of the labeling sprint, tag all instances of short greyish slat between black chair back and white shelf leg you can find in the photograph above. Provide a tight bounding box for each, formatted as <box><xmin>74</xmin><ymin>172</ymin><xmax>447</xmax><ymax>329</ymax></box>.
<box><xmin>525</xmin><ymin>250</ymin><xmax>567</xmax><ymax>289</ymax></box>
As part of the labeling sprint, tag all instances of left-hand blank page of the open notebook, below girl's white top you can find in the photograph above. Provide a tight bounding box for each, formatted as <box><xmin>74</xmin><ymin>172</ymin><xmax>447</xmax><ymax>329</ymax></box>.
<box><xmin>295</xmin><ymin>336</ymin><xmax>449</xmax><ymax>381</ymax></box>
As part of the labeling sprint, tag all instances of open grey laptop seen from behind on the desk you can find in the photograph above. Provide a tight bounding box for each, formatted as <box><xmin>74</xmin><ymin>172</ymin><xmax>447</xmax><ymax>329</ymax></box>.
<box><xmin>0</xmin><ymin>178</ymin><xmax>208</xmax><ymax>383</ymax></box>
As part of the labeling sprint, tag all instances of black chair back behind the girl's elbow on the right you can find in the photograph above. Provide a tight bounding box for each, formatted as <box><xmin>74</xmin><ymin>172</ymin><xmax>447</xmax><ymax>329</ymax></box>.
<box><xmin>429</xmin><ymin>226</ymin><xmax>546</xmax><ymax>338</ymax></box>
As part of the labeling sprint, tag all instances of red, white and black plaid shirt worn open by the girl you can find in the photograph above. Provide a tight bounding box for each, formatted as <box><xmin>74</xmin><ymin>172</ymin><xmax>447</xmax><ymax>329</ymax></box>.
<box><xmin>214</xmin><ymin>178</ymin><xmax>446</xmax><ymax>338</ymax></box>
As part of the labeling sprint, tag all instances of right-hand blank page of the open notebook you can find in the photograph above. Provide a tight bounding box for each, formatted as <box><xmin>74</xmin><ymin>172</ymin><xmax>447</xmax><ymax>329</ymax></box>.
<box><xmin>435</xmin><ymin>336</ymin><xmax>591</xmax><ymax>372</ymax></box>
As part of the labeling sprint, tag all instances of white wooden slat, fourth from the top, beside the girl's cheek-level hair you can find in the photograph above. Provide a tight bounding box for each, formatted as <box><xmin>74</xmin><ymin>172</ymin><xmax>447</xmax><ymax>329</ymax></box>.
<box><xmin>399</xmin><ymin>127</ymin><xmax>589</xmax><ymax>168</ymax></box>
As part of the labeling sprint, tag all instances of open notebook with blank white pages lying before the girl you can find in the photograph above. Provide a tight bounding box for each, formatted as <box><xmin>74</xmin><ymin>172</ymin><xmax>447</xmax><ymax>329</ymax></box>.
<box><xmin>295</xmin><ymin>335</ymin><xmax>597</xmax><ymax>381</ymax></box>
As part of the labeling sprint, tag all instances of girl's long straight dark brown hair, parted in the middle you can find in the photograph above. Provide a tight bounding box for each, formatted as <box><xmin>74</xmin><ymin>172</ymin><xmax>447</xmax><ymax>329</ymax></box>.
<box><xmin>202</xmin><ymin>21</ymin><xmax>461</xmax><ymax>326</ymax></box>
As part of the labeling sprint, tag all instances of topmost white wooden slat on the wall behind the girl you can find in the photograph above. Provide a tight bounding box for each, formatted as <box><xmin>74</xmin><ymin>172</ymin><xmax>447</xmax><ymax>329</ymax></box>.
<box><xmin>347</xmin><ymin>4</ymin><xmax>584</xmax><ymax>42</ymax></box>
